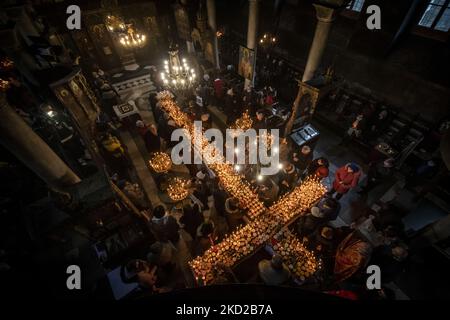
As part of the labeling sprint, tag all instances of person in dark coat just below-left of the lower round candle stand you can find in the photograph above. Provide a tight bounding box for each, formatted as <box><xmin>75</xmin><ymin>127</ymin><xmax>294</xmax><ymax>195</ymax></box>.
<box><xmin>150</xmin><ymin>206</ymin><xmax>180</xmax><ymax>244</ymax></box>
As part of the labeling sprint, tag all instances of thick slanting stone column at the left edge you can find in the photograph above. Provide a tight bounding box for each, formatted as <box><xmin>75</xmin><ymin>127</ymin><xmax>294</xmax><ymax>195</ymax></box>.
<box><xmin>0</xmin><ymin>93</ymin><xmax>81</xmax><ymax>191</ymax></box>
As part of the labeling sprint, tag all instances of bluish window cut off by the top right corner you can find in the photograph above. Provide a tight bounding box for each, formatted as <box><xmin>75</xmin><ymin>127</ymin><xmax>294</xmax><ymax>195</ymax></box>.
<box><xmin>418</xmin><ymin>0</ymin><xmax>450</xmax><ymax>32</ymax></box>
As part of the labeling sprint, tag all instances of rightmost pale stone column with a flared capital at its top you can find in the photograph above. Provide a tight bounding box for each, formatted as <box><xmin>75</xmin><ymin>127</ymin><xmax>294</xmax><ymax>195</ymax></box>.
<box><xmin>302</xmin><ymin>4</ymin><xmax>336</xmax><ymax>82</ymax></box>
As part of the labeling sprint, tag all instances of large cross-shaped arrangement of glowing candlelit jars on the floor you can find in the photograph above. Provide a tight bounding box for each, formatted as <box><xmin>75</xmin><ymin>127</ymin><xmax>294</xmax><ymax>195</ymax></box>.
<box><xmin>159</xmin><ymin>92</ymin><xmax>326</xmax><ymax>284</ymax></box>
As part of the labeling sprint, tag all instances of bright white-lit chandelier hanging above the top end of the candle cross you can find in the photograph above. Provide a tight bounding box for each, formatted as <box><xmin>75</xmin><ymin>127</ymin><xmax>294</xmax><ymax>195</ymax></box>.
<box><xmin>161</xmin><ymin>46</ymin><xmax>196</xmax><ymax>90</ymax></box>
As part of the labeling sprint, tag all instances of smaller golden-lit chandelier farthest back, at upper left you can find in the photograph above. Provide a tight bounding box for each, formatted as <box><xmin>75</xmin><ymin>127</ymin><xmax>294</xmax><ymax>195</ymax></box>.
<box><xmin>106</xmin><ymin>15</ymin><xmax>146</xmax><ymax>48</ymax></box>
